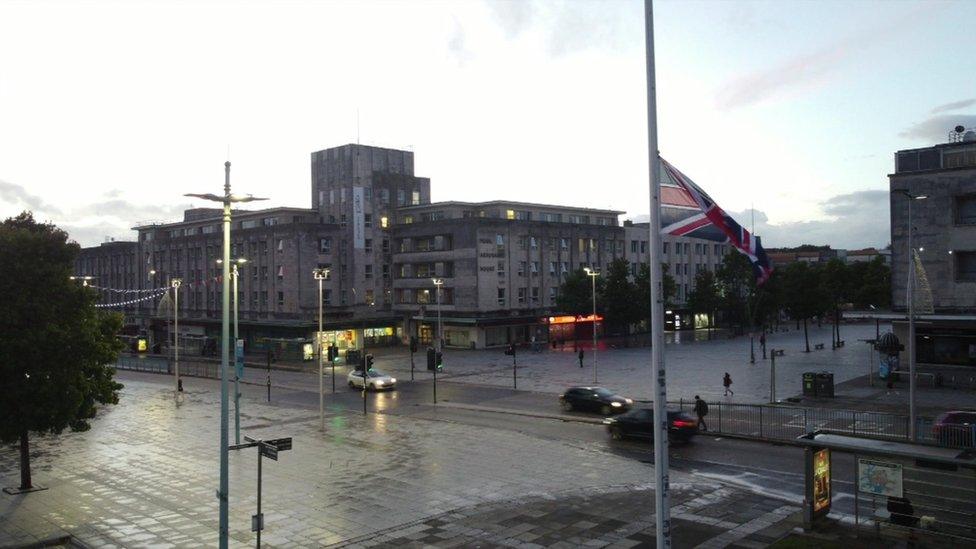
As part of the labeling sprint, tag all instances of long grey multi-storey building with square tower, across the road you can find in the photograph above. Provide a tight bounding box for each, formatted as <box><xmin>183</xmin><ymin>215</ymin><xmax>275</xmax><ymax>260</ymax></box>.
<box><xmin>77</xmin><ymin>145</ymin><xmax>725</xmax><ymax>349</ymax></box>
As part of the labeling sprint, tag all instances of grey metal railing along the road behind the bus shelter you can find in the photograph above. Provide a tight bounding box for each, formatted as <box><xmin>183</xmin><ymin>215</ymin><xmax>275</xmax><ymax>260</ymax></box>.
<box><xmin>671</xmin><ymin>400</ymin><xmax>976</xmax><ymax>448</ymax></box>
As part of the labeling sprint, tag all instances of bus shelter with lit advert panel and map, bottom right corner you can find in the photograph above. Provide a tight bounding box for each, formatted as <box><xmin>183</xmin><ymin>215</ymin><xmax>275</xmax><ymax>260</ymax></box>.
<box><xmin>797</xmin><ymin>431</ymin><xmax>976</xmax><ymax>546</ymax></box>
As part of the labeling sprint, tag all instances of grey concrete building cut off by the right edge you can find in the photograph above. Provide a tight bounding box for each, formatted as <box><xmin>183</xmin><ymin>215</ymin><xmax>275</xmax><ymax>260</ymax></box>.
<box><xmin>888</xmin><ymin>131</ymin><xmax>976</xmax><ymax>366</ymax></box>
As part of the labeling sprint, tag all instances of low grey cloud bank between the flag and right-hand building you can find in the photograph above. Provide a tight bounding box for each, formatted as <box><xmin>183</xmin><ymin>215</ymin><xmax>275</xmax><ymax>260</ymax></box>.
<box><xmin>632</xmin><ymin>189</ymin><xmax>891</xmax><ymax>250</ymax></box>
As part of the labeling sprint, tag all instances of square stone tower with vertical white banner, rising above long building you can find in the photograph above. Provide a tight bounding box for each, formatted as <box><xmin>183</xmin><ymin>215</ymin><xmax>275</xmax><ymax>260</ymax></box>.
<box><xmin>311</xmin><ymin>144</ymin><xmax>430</xmax><ymax>310</ymax></box>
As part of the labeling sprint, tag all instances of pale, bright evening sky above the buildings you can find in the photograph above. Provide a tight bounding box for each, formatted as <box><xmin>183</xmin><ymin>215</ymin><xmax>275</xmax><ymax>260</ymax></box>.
<box><xmin>0</xmin><ymin>0</ymin><xmax>976</xmax><ymax>249</ymax></box>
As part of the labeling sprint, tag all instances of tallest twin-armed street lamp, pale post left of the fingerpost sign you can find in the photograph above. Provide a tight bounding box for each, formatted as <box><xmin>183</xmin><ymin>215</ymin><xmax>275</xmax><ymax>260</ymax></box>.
<box><xmin>183</xmin><ymin>161</ymin><xmax>267</xmax><ymax>549</ymax></box>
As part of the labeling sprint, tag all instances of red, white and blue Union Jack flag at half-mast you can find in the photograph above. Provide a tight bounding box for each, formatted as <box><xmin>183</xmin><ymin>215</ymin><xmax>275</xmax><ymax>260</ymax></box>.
<box><xmin>661</xmin><ymin>158</ymin><xmax>773</xmax><ymax>284</ymax></box>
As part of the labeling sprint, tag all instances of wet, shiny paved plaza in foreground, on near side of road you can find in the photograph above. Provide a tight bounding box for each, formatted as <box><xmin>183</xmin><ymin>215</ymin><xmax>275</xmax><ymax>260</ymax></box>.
<box><xmin>0</xmin><ymin>373</ymin><xmax>808</xmax><ymax>547</ymax></box>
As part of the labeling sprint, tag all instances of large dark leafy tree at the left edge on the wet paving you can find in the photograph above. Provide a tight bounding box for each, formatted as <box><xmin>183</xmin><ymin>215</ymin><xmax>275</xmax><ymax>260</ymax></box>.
<box><xmin>0</xmin><ymin>212</ymin><xmax>123</xmax><ymax>490</ymax></box>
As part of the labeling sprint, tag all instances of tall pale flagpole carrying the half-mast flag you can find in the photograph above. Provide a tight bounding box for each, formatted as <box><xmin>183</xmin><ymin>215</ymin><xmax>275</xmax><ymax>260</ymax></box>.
<box><xmin>644</xmin><ymin>0</ymin><xmax>671</xmax><ymax>549</ymax></box>
